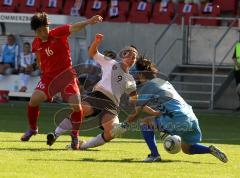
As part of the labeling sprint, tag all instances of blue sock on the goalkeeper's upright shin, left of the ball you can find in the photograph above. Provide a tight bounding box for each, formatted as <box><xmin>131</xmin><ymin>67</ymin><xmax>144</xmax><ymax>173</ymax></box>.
<box><xmin>141</xmin><ymin>125</ymin><xmax>159</xmax><ymax>156</ymax></box>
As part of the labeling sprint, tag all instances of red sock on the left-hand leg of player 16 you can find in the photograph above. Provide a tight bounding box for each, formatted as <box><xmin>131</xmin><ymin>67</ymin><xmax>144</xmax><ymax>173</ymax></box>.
<box><xmin>28</xmin><ymin>105</ymin><xmax>40</xmax><ymax>130</ymax></box>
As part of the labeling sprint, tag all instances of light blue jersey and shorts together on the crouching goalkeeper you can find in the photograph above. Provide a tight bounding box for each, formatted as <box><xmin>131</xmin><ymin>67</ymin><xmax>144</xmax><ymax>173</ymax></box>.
<box><xmin>137</xmin><ymin>78</ymin><xmax>202</xmax><ymax>144</ymax></box>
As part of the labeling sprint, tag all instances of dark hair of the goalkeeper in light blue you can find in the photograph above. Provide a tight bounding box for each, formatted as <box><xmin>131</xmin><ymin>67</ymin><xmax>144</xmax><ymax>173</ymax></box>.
<box><xmin>136</xmin><ymin>55</ymin><xmax>158</xmax><ymax>79</ymax></box>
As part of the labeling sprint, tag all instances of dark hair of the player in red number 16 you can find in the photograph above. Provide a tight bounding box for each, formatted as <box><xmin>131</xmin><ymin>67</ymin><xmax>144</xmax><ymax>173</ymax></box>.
<box><xmin>31</xmin><ymin>12</ymin><xmax>49</xmax><ymax>31</ymax></box>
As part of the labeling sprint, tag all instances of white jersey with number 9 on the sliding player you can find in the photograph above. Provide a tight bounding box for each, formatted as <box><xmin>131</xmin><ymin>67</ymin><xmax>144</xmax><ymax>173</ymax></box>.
<box><xmin>93</xmin><ymin>52</ymin><xmax>136</xmax><ymax>105</ymax></box>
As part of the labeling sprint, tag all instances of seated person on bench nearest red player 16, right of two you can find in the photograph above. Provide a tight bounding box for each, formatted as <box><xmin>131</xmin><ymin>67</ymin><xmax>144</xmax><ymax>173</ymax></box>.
<box><xmin>19</xmin><ymin>42</ymin><xmax>39</xmax><ymax>92</ymax></box>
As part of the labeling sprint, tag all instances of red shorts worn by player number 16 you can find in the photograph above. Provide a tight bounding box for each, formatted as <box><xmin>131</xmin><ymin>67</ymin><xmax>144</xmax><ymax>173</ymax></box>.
<box><xmin>35</xmin><ymin>70</ymin><xmax>80</xmax><ymax>102</ymax></box>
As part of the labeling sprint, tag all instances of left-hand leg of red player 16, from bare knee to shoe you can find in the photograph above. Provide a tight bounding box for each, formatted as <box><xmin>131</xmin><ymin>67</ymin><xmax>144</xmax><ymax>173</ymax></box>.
<box><xmin>21</xmin><ymin>90</ymin><xmax>47</xmax><ymax>141</ymax></box>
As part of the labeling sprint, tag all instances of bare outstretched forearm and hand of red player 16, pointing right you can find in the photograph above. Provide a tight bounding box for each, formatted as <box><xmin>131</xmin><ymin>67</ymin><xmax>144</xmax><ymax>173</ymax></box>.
<box><xmin>70</xmin><ymin>15</ymin><xmax>103</xmax><ymax>33</ymax></box>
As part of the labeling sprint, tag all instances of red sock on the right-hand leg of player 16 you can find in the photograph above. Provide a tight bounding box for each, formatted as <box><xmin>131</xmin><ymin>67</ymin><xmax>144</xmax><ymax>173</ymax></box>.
<box><xmin>71</xmin><ymin>109</ymin><xmax>83</xmax><ymax>136</ymax></box>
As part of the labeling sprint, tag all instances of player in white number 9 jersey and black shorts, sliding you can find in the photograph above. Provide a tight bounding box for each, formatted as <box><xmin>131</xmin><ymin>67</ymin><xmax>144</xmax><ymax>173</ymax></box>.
<box><xmin>47</xmin><ymin>34</ymin><xmax>138</xmax><ymax>149</ymax></box>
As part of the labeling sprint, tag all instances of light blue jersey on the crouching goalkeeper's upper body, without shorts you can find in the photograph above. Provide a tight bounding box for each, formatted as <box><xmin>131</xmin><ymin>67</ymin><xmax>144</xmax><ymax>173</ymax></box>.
<box><xmin>137</xmin><ymin>78</ymin><xmax>195</xmax><ymax>119</ymax></box>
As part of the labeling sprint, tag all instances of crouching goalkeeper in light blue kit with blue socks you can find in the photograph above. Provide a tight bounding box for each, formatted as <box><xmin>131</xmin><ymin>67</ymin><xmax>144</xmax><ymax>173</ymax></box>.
<box><xmin>112</xmin><ymin>58</ymin><xmax>228</xmax><ymax>163</ymax></box>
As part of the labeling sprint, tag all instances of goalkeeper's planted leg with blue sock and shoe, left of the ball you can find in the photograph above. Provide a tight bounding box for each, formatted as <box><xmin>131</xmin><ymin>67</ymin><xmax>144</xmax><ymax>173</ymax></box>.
<box><xmin>140</xmin><ymin>117</ymin><xmax>161</xmax><ymax>162</ymax></box>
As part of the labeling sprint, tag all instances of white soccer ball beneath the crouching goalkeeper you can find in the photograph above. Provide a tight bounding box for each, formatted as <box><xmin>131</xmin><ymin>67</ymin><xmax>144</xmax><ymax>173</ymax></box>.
<box><xmin>163</xmin><ymin>135</ymin><xmax>181</xmax><ymax>154</ymax></box>
